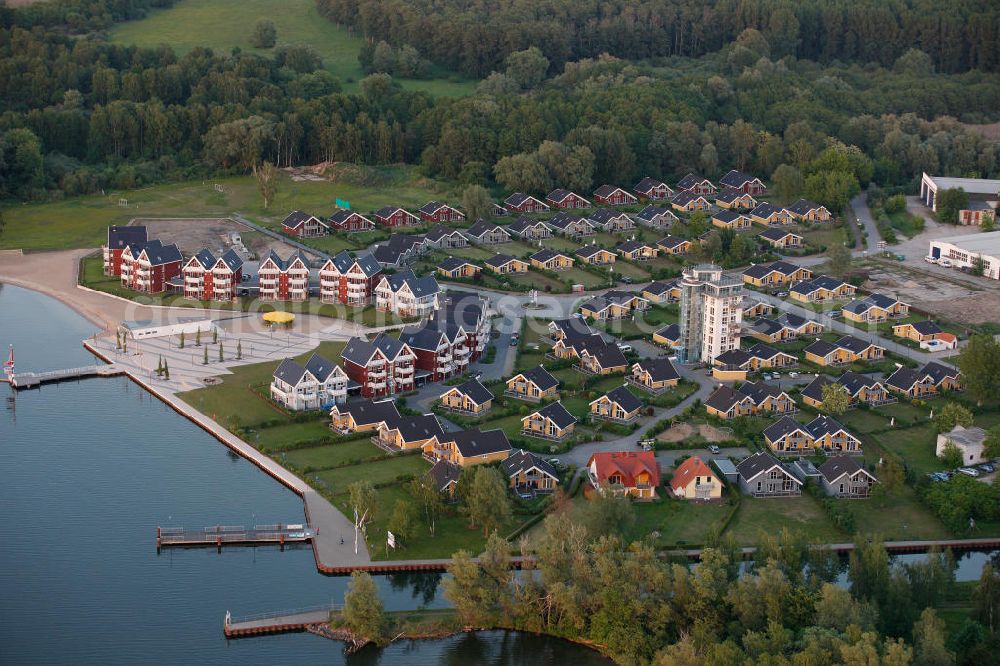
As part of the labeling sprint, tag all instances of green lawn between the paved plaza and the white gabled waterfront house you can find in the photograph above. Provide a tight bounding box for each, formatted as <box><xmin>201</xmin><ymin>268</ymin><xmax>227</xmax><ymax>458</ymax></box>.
<box><xmin>173</xmin><ymin>341</ymin><xmax>347</xmax><ymax>428</ymax></box>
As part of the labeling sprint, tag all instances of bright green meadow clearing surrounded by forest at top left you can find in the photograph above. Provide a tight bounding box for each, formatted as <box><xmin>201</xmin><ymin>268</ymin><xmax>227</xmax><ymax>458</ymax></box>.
<box><xmin>110</xmin><ymin>0</ymin><xmax>476</xmax><ymax>97</ymax></box>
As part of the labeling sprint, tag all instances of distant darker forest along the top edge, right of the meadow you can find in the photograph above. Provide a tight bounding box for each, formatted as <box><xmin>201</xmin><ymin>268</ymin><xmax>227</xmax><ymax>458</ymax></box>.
<box><xmin>316</xmin><ymin>0</ymin><xmax>1000</xmax><ymax>78</ymax></box>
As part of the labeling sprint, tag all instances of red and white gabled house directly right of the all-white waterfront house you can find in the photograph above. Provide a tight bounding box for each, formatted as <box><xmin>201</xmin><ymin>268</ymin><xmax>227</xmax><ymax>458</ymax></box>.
<box><xmin>341</xmin><ymin>333</ymin><xmax>417</xmax><ymax>398</ymax></box>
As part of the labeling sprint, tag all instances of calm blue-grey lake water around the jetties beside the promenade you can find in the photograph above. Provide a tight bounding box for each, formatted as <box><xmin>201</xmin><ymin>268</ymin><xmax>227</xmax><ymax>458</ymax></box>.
<box><xmin>0</xmin><ymin>285</ymin><xmax>608</xmax><ymax>666</ymax></box>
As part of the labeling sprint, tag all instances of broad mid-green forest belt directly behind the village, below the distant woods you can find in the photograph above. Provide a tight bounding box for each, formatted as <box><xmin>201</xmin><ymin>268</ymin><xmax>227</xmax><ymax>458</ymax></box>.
<box><xmin>0</xmin><ymin>0</ymin><xmax>1000</xmax><ymax>207</ymax></box>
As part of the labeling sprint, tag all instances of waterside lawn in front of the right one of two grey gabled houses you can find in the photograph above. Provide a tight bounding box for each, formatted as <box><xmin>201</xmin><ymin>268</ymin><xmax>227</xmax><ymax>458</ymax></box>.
<box><xmin>852</xmin><ymin>486</ymin><xmax>954</xmax><ymax>541</ymax></box>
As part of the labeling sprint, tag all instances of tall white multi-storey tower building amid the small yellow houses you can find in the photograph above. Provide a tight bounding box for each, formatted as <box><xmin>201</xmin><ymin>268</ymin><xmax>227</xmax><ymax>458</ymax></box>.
<box><xmin>677</xmin><ymin>264</ymin><xmax>743</xmax><ymax>363</ymax></box>
